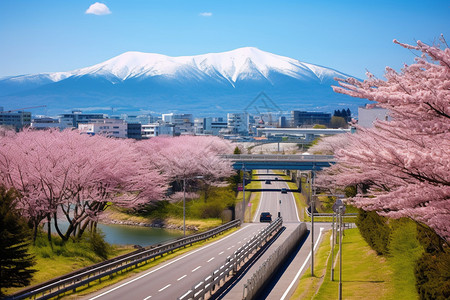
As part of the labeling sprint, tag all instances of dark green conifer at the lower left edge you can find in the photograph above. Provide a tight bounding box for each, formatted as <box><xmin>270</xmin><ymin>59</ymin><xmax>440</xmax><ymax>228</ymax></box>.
<box><xmin>0</xmin><ymin>187</ymin><xmax>36</xmax><ymax>297</ymax></box>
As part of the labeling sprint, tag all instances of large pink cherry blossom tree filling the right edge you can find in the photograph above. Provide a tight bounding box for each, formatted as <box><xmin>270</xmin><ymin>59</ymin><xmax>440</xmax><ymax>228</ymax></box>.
<box><xmin>318</xmin><ymin>40</ymin><xmax>450</xmax><ymax>240</ymax></box>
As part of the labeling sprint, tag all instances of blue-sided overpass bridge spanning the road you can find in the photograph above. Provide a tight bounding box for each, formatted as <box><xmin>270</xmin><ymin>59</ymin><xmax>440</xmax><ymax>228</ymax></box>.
<box><xmin>223</xmin><ymin>154</ymin><xmax>336</xmax><ymax>171</ymax></box>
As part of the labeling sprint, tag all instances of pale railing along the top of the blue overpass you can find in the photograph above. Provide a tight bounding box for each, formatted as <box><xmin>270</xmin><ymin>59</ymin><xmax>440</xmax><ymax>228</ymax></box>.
<box><xmin>221</xmin><ymin>154</ymin><xmax>335</xmax><ymax>162</ymax></box>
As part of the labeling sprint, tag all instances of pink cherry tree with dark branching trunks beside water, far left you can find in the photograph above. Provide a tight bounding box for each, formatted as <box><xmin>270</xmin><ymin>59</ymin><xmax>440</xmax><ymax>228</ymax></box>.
<box><xmin>0</xmin><ymin>130</ymin><xmax>167</xmax><ymax>240</ymax></box>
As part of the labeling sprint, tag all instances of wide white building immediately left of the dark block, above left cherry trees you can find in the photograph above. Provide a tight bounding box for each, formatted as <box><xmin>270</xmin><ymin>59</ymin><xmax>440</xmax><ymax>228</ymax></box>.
<box><xmin>78</xmin><ymin>119</ymin><xmax>127</xmax><ymax>138</ymax></box>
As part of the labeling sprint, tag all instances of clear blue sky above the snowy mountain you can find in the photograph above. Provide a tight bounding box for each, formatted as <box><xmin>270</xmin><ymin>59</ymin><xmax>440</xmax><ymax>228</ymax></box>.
<box><xmin>0</xmin><ymin>0</ymin><xmax>450</xmax><ymax>78</ymax></box>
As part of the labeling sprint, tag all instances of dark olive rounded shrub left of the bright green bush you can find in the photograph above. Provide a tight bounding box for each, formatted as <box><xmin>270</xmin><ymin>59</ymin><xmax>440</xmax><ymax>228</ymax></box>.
<box><xmin>356</xmin><ymin>209</ymin><xmax>391</xmax><ymax>255</ymax></box>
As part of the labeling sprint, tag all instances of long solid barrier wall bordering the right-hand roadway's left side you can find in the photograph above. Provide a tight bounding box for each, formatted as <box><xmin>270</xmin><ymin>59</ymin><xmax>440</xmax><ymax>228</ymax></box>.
<box><xmin>242</xmin><ymin>223</ymin><xmax>306</xmax><ymax>300</ymax></box>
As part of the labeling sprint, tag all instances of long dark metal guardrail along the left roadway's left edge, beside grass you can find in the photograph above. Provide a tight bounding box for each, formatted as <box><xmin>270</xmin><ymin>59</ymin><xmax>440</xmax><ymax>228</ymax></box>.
<box><xmin>6</xmin><ymin>220</ymin><xmax>241</xmax><ymax>300</ymax></box>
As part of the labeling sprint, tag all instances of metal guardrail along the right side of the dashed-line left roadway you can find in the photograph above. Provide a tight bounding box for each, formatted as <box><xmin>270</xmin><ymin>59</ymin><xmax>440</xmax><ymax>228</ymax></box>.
<box><xmin>178</xmin><ymin>218</ymin><xmax>283</xmax><ymax>300</ymax></box>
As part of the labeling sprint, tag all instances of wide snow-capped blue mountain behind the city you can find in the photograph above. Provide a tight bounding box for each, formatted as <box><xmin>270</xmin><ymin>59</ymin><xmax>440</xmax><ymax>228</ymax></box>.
<box><xmin>0</xmin><ymin>47</ymin><xmax>366</xmax><ymax>114</ymax></box>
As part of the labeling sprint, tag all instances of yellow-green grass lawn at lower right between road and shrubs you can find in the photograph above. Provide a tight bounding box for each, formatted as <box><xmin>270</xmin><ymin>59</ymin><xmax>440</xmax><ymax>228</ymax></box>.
<box><xmin>291</xmin><ymin>228</ymin><xmax>420</xmax><ymax>300</ymax></box>
